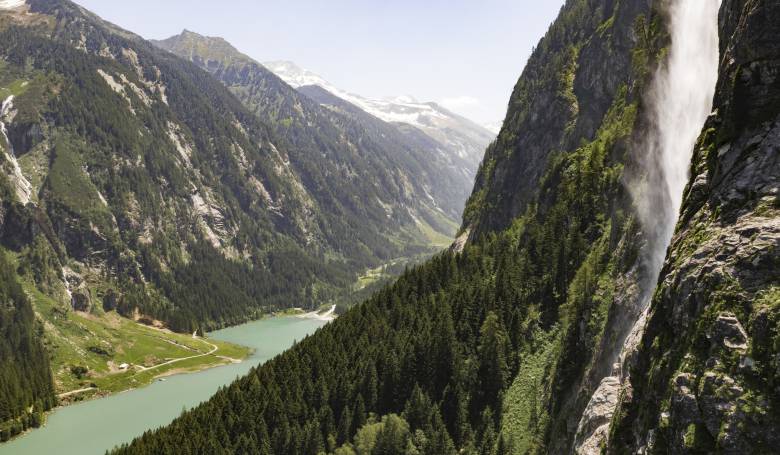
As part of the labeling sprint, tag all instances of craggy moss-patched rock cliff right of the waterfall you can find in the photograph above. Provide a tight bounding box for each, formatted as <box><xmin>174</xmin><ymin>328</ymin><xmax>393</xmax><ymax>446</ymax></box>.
<box><xmin>609</xmin><ymin>0</ymin><xmax>780</xmax><ymax>453</ymax></box>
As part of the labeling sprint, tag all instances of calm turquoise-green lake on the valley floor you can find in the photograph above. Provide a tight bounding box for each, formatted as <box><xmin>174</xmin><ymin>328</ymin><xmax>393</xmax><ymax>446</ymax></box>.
<box><xmin>0</xmin><ymin>317</ymin><xmax>325</xmax><ymax>455</ymax></box>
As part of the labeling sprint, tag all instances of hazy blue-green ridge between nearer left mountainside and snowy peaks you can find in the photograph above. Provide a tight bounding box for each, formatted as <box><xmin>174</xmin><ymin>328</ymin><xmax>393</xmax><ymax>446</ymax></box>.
<box><xmin>155</xmin><ymin>28</ymin><xmax>469</xmax><ymax>239</ymax></box>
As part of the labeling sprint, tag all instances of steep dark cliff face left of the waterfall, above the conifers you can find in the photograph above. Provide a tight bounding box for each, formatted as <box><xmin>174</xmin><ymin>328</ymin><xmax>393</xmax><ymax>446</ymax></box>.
<box><xmin>463</xmin><ymin>0</ymin><xmax>651</xmax><ymax>239</ymax></box>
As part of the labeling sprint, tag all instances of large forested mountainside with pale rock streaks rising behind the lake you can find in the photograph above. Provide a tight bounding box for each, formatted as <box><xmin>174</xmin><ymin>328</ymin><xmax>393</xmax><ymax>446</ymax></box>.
<box><xmin>0</xmin><ymin>0</ymin><xmax>450</xmax><ymax>338</ymax></box>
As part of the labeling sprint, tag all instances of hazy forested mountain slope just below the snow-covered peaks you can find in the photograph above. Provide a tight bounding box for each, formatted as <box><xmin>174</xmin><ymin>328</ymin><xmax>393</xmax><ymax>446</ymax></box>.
<box><xmin>156</xmin><ymin>31</ymin><xmax>472</xmax><ymax>235</ymax></box>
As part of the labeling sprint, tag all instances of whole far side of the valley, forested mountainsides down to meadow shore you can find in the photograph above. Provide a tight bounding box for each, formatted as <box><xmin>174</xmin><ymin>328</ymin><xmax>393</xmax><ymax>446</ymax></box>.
<box><xmin>0</xmin><ymin>1</ymin><xmax>491</xmax><ymax>439</ymax></box>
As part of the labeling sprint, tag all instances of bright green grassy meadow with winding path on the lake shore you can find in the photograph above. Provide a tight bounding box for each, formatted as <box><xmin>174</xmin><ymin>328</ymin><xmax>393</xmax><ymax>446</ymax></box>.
<box><xmin>24</xmin><ymin>283</ymin><xmax>249</xmax><ymax>400</ymax></box>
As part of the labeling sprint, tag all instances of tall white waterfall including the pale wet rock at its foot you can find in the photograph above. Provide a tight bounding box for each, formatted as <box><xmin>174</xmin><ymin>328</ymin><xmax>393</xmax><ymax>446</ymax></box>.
<box><xmin>575</xmin><ymin>0</ymin><xmax>721</xmax><ymax>454</ymax></box>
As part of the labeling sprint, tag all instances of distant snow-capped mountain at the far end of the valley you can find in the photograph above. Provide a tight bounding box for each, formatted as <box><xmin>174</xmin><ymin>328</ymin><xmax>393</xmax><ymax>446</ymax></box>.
<box><xmin>263</xmin><ymin>61</ymin><xmax>496</xmax><ymax>175</ymax></box>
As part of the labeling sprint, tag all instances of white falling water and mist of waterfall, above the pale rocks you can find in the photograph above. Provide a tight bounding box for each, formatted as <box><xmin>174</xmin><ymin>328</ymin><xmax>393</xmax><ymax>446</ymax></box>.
<box><xmin>634</xmin><ymin>0</ymin><xmax>720</xmax><ymax>305</ymax></box>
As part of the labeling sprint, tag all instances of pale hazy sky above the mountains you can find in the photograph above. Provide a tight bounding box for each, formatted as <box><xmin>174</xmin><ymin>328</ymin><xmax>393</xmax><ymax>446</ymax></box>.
<box><xmin>75</xmin><ymin>0</ymin><xmax>563</xmax><ymax>126</ymax></box>
